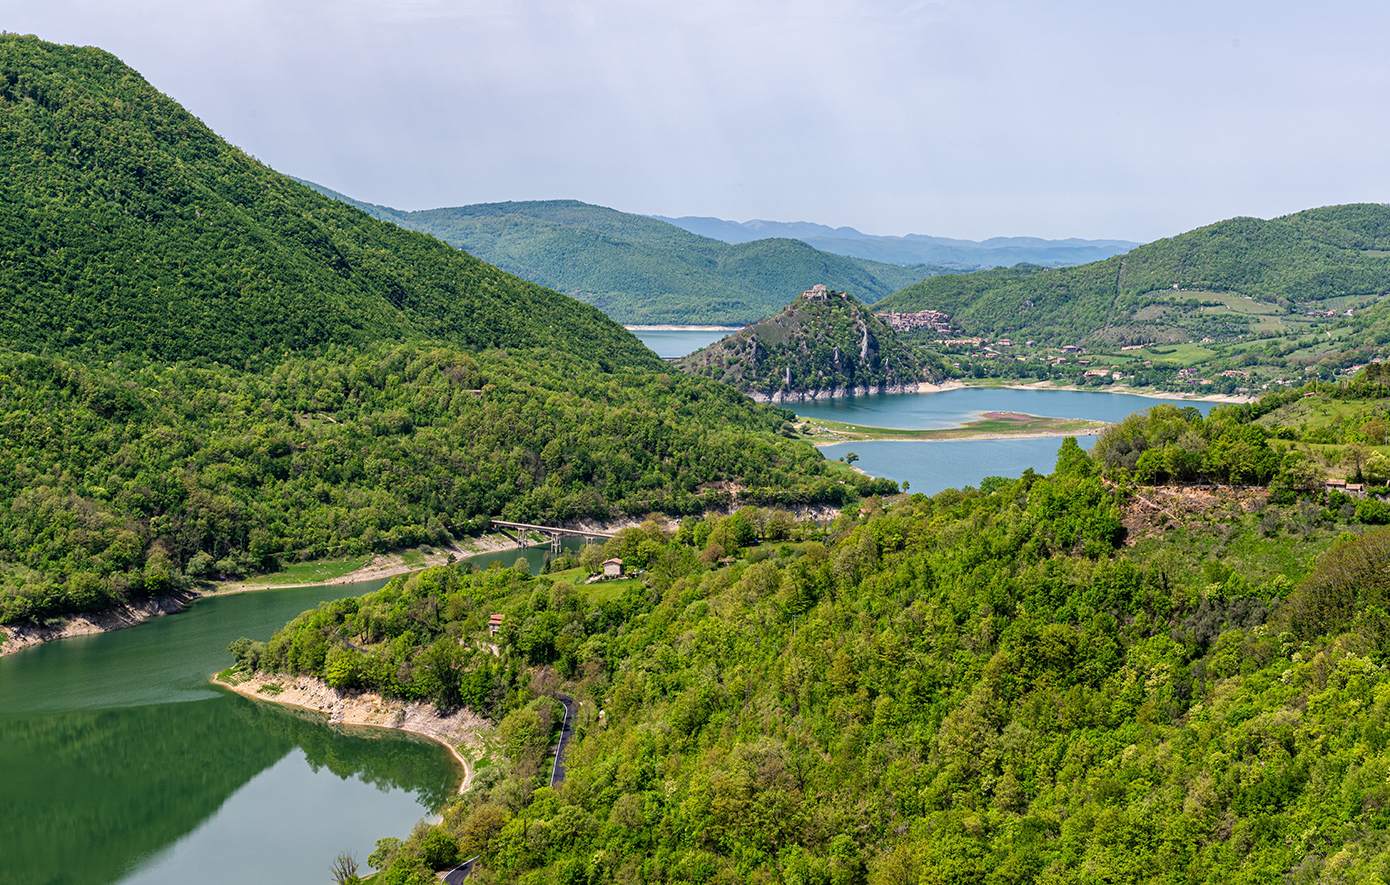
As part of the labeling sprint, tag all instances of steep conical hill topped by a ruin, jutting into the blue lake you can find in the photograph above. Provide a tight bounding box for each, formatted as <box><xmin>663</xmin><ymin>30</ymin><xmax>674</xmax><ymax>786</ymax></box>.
<box><xmin>680</xmin><ymin>286</ymin><xmax>926</xmax><ymax>403</ymax></box>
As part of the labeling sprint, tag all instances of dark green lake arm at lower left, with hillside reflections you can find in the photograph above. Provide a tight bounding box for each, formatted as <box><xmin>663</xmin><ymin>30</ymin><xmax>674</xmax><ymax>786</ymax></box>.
<box><xmin>0</xmin><ymin>546</ymin><xmax>578</xmax><ymax>885</ymax></box>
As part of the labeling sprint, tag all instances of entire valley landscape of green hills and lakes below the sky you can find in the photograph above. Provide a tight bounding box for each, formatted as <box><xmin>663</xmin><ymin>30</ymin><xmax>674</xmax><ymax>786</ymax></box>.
<box><xmin>13</xmin><ymin>24</ymin><xmax>1390</xmax><ymax>885</ymax></box>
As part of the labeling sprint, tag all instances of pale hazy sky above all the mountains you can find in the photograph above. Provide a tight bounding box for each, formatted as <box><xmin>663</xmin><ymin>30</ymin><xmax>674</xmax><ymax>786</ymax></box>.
<box><xmin>0</xmin><ymin>0</ymin><xmax>1390</xmax><ymax>240</ymax></box>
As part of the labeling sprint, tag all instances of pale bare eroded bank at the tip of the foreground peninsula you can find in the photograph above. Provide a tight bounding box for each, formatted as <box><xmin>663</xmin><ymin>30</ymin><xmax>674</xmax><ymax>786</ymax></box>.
<box><xmin>211</xmin><ymin>674</ymin><xmax>491</xmax><ymax>793</ymax></box>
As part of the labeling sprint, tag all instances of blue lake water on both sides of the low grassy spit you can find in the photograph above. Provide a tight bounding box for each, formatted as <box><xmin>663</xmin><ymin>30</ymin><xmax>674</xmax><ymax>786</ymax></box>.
<box><xmin>795</xmin><ymin>388</ymin><xmax>1215</xmax><ymax>495</ymax></box>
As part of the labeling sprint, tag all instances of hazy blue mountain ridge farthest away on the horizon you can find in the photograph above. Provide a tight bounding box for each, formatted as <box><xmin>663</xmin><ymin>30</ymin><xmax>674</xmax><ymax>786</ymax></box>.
<box><xmin>652</xmin><ymin>215</ymin><xmax>1138</xmax><ymax>270</ymax></box>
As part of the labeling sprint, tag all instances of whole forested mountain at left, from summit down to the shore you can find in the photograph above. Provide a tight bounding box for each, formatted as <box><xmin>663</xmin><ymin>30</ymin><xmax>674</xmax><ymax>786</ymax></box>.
<box><xmin>0</xmin><ymin>35</ymin><xmax>891</xmax><ymax>621</ymax></box>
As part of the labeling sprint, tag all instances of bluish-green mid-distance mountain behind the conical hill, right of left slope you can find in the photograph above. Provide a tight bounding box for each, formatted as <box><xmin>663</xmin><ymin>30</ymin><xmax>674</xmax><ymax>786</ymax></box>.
<box><xmin>303</xmin><ymin>185</ymin><xmax>944</xmax><ymax>325</ymax></box>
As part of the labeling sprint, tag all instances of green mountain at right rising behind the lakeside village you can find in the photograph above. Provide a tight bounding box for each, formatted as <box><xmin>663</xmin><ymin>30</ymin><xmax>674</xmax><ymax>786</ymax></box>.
<box><xmin>876</xmin><ymin>204</ymin><xmax>1390</xmax><ymax>345</ymax></box>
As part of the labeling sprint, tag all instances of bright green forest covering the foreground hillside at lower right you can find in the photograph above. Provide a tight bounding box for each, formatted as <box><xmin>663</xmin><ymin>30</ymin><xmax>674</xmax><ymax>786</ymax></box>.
<box><xmin>247</xmin><ymin>383</ymin><xmax>1390</xmax><ymax>885</ymax></box>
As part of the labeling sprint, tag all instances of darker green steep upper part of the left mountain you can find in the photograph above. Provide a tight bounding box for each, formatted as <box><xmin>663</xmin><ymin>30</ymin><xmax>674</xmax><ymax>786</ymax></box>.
<box><xmin>0</xmin><ymin>36</ymin><xmax>651</xmax><ymax>367</ymax></box>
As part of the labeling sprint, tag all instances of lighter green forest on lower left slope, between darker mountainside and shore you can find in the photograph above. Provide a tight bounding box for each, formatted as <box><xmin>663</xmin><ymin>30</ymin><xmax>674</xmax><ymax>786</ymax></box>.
<box><xmin>0</xmin><ymin>337</ymin><xmax>892</xmax><ymax>621</ymax></box>
